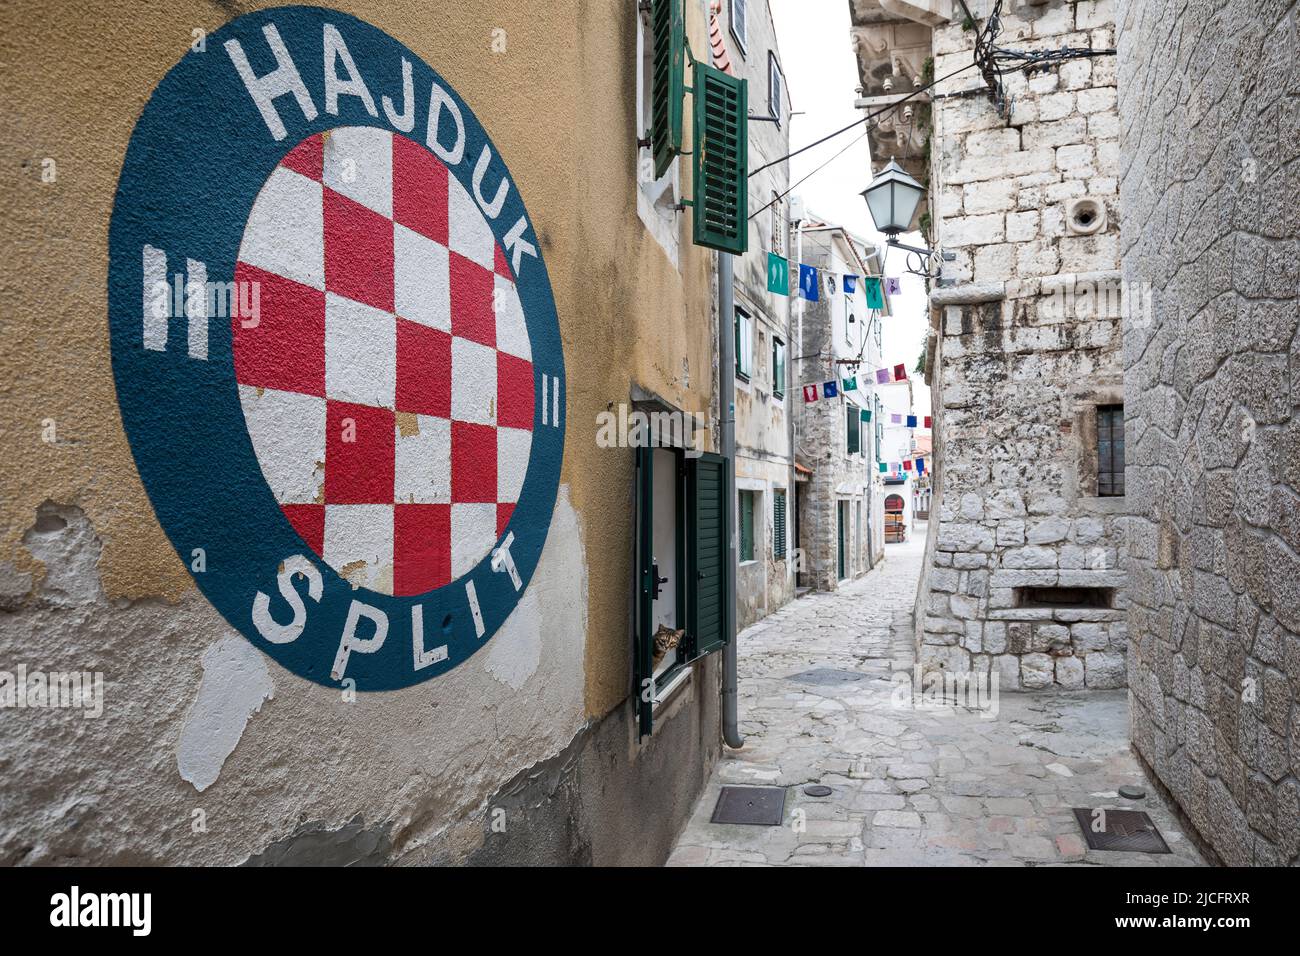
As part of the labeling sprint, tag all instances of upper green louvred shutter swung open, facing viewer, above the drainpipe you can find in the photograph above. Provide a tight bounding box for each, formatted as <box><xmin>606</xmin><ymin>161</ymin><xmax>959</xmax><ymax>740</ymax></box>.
<box><xmin>692</xmin><ymin>61</ymin><xmax>749</xmax><ymax>255</ymax></box>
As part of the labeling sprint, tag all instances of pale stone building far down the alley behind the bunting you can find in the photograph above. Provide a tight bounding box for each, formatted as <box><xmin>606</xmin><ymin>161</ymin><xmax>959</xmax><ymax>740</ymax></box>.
<box><xmin>792</xmin><ymin>216</ymin><xmax>889</xmax><ymax>591</ymax></box>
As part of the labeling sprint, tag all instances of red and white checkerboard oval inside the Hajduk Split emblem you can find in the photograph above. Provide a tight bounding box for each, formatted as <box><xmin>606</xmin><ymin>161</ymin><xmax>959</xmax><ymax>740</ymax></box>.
<box><xmin>233</xmin><ymin>126</ymin><xmax>534</xmax><ymax>596</ymax></box>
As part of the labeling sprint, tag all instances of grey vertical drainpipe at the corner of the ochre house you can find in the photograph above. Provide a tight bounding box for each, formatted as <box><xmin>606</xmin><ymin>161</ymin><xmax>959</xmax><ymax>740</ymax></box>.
<box><xmin>718</xmin><ymin>252</ymin><xmax>745</xmax><ymax>749</ymax></box>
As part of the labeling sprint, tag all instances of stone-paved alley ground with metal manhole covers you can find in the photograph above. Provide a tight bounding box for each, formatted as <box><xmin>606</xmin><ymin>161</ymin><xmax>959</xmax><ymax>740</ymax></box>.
<box><xmin>668</xmin><ymin>524</ymin><xmax>1203</xmax><ymax>866</ymax></box>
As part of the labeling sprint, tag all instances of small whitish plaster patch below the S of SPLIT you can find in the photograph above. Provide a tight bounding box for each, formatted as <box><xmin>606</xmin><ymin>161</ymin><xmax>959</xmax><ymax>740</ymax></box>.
<box><xmin>176</xmin><ymin>636</ymin><xmax>276</xmax><ymax>793</ymax></box>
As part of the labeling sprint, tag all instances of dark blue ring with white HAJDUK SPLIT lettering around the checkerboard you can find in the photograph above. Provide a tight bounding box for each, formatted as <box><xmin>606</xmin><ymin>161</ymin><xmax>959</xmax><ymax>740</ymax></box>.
<box><xmin>108</xmin><ymin>7</ymin><xmax>567</xmax><ymax>691</ymax></box>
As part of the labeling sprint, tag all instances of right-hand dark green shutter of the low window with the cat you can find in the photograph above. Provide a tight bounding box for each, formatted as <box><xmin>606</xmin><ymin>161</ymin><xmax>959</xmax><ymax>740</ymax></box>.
<box><xmin>686</xmin><ymin>453</ymin><xmax>731</xmax><ymax>657</ymax></box>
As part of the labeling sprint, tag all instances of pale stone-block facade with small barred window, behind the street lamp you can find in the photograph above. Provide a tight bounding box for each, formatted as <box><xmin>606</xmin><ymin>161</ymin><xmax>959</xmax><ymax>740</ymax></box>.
<box><xmin>915</xmin><ymin>0</ymin><xmax>1127</xmax><ymax>689</ymax></box>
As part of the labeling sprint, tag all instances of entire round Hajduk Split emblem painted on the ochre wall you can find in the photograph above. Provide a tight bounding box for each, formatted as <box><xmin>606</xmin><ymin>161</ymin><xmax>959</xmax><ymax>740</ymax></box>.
<box><xmin>109</xmin><ymin>7</ymin><xmax>564</xmax><ymax>691</ymax></box>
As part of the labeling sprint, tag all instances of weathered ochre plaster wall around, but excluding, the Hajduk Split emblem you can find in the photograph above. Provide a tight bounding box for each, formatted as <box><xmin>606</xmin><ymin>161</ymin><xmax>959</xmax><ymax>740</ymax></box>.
<box><xmin>0</xmin><ymin>0</ymin><xmax>719</xmax><ymax>864</ymax></box>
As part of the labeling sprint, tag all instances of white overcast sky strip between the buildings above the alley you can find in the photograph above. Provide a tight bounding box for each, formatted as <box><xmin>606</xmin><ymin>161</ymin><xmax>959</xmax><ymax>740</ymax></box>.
<box><xmin>770</xmin><ymin>0</ymin><xmax>930</xmax><ymax>429</ymax></box>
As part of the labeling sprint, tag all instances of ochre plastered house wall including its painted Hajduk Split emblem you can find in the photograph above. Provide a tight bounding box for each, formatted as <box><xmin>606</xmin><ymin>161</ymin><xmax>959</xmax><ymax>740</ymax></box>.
<box><xmin>0</xmin><ymin>0</ymin><xmax>731</xmax><ymax>864</ymax></box>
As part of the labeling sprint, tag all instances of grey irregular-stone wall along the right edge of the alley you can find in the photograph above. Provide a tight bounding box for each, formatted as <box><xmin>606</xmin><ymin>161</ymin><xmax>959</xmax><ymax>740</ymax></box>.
<box><xmin>1118</xmin><ymin>0</ymin><xmax>1300</xmax><ymax>865</ymax></box>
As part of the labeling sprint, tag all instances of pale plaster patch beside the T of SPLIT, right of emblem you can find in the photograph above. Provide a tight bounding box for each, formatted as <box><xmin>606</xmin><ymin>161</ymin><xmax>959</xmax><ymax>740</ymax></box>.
<box><xmin>484</xmin><ymin>485</ymin><xmax>586</xmax><ymax>691</ymax></box>
